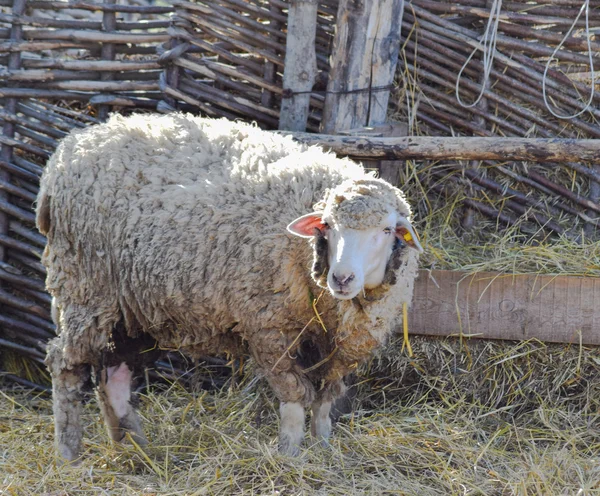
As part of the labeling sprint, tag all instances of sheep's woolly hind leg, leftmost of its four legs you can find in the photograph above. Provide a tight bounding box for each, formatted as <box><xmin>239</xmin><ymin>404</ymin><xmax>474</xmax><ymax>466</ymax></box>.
<box><xmin>52</xmin><ymin>365</ymin><xmax>89</xmax><ymax>462</ymax></box>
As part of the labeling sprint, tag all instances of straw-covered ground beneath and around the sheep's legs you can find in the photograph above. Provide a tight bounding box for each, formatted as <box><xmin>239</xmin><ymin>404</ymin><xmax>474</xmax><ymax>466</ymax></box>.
<box><xmin>0</xmin><ymin>337</ymin><xmax>600</xmax><ymax>496</ymax></box>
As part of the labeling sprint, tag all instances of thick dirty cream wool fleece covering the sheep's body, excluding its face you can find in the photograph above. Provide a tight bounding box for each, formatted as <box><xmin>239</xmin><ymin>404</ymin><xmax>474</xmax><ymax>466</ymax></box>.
<box><xmin>37</xmin><ymin>114</ymin><xmax>417</xmax><ymax>404</ymax></box>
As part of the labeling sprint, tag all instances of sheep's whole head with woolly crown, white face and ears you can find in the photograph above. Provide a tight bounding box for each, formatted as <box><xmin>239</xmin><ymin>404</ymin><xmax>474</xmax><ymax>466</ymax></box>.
<box><xmin>288</xmin><ymin>178</ymin><xmax>423</xmax><ymax>300</ymax></box>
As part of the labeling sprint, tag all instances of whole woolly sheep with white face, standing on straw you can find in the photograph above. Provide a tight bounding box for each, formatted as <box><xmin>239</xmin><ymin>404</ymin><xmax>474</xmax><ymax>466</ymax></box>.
<box><xmin>36</xmin><ymin>113</ymin><xmax>422</xmax><ymax>461</ymax></box>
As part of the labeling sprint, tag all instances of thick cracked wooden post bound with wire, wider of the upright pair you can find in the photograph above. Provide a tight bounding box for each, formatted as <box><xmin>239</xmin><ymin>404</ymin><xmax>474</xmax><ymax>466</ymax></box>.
<box><xmin>321</xmin><ymin>0</ymin><xmax>404</xmax><ymax>134</ymax></box>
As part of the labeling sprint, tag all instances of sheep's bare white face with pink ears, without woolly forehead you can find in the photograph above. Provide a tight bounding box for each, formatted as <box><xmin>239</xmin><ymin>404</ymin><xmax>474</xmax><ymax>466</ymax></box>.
<box><xmin>288</xmin><ymin>208</ymin><xmax>423</xmax><ymax>300</ymax></box>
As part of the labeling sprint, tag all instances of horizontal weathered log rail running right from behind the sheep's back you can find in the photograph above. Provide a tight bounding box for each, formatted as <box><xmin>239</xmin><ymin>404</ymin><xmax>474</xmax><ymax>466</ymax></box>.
<box><xmin>290</xmin><ymin>133</ymin><xmax>600</xmax><ymax>162</ymax></box>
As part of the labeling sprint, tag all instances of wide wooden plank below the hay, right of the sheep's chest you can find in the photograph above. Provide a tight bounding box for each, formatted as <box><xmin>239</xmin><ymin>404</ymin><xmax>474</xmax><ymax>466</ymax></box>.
<box><xmin>409</xmin><ymin>270</ymin><xmax>600</xmax><ymax>345</ymax></box>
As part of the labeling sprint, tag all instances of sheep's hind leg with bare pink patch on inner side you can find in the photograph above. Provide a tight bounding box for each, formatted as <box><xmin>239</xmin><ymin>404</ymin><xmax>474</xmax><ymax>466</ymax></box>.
<box><xmin>97</xmin><ymin>362</ymin><xmax>148</xmax><ymax>446</ymax></box>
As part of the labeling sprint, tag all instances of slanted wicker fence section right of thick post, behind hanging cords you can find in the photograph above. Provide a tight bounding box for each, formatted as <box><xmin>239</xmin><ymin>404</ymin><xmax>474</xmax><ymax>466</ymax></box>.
<box><xmin>391</xmin><ymin>0</ymin><xmax>600</xmax><ymax>239</ymax></box>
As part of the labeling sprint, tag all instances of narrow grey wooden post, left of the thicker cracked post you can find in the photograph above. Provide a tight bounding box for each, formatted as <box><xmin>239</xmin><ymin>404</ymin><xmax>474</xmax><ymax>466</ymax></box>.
<box><xmin>279</xmin><ymin>0</ymin><xmax>317</xmax><ymax>131</ymax></box>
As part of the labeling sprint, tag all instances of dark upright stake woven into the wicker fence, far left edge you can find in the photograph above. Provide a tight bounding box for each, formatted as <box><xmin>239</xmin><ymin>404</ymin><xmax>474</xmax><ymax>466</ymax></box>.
<box><xmin>0</xmin><ymin>0</ymin><xmax>27</xmax><ymax>262</ymax></box>
